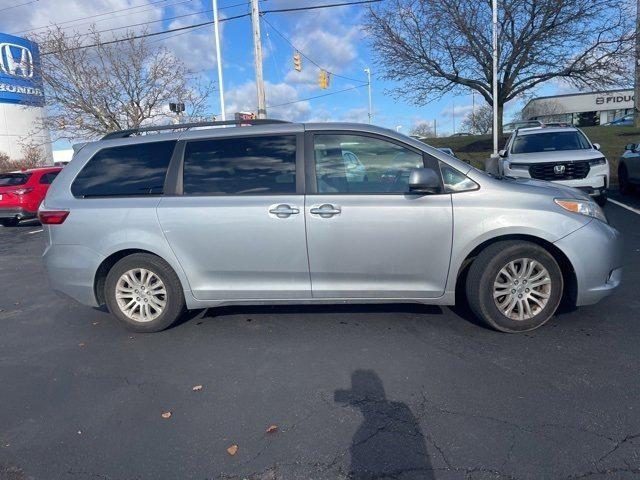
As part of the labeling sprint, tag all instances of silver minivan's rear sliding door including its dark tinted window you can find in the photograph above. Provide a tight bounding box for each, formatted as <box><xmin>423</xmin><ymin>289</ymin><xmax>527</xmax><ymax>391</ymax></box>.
<box><xmin>158</xmin><ymin>134</ymin><xmax>311</xmax><ymax>300</ymax></box>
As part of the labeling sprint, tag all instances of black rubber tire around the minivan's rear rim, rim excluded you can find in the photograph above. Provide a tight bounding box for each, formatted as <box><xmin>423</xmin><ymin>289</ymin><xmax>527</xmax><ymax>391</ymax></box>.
<box><xmin>104</xmin><ymin>253</ymin><xmax>185</xmax><ymax>332</ymax></box>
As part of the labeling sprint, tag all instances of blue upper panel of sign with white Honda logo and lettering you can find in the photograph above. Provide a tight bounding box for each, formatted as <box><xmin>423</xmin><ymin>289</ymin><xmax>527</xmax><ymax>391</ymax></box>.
<box><xmin>0</xmin><ymin>33</ymin><xmax>44</xmax><ymax>106</ymax></box>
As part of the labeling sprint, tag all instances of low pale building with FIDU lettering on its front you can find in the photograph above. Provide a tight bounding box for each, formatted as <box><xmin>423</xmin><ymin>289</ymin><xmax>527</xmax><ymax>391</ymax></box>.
<box><xmin>522</xmin><ymin>89</ymin><xmax>633</xmax><ymax>127</ymax></box>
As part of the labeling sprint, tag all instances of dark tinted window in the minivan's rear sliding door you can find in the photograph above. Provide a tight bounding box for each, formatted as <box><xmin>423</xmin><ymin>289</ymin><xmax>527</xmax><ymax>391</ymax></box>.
<box><xmin>183</xmin><ymin>135</ymin><xmax>296</xmax><ymax>195</ymax></box>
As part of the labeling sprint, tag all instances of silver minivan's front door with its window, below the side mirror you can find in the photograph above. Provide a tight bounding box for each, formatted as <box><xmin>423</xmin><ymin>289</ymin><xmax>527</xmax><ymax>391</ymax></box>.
<box><xmin>305</xmin><ymin>132</ymin><xmax>453</xmax><ymax>298</ymax></box>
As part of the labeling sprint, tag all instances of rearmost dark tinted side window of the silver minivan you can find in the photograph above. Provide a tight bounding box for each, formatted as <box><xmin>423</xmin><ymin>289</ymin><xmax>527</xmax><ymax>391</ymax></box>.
<box><xmin>71</xmin><ymin>141</ymin><xmax>176</xmax><ymax>197</ymax></box>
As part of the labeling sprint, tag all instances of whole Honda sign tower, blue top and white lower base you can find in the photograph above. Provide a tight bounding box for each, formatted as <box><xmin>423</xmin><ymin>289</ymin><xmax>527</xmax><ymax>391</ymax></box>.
<box><xmin>0</xmin><ymin>33</ymin><xmax>52</xmax><ymax>162</ymax></box>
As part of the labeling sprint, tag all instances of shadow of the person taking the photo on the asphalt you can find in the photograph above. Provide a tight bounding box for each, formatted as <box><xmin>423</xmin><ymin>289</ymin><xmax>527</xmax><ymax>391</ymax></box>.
<box><xmin>334</xmin><ymin>370</ymin><xmax>434</xmax><ymax>480</ymax></box>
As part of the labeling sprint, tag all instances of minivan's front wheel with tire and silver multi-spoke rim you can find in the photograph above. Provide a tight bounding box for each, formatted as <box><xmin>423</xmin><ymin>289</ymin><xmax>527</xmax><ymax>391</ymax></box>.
<box><xmin>466</xmin><ymin>241</ymin><xmax>563</xmax><ymax>333</ymax></box>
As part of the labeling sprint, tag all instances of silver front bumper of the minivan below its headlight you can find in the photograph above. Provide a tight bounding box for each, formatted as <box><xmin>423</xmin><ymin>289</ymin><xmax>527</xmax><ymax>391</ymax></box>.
<box><xmin>555</xmin><ymin>220</ymin><xmax>623</xmax><ymax>305</ymax></box>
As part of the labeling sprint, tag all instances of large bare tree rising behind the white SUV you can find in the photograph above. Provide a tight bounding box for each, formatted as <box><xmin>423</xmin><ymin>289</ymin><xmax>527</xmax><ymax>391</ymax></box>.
<box><xmin>366</xmin><ymin>0</ymin><xmax>635</xmax><ymax>133</ymax></box>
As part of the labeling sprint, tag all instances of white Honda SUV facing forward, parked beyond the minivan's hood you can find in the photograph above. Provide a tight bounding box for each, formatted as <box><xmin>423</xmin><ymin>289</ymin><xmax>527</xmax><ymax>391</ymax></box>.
<box><xmin>499</xmin><ymin>127</ymin><xmax>610</xmax><ymax>205</ymax></box>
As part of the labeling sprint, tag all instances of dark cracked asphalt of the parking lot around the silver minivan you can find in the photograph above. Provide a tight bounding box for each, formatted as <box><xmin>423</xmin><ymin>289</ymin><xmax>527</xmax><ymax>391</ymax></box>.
<box><xmin>0</xmin><ymin>197</ymin><xmax>640</xmax><ymax>480</ymax></box>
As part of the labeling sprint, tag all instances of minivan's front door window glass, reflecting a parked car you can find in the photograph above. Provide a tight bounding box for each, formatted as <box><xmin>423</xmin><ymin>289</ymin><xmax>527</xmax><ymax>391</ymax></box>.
<box><xmin>314</xmin><ymin>134</ymin><xmax>424</xmax><ymax>194</ymax></box>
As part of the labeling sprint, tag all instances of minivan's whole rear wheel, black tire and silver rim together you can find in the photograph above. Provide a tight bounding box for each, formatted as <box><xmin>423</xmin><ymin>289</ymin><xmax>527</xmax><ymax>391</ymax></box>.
<box><xmin>105</xmin><ymin>253</ymin><xmax>184</xmax><ymax>332</ymax></box>
